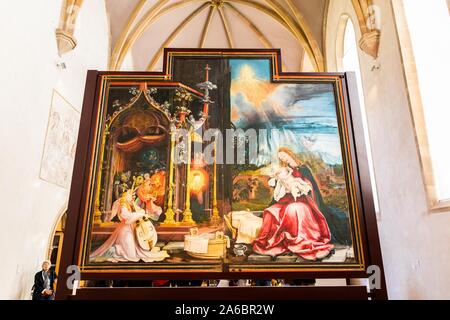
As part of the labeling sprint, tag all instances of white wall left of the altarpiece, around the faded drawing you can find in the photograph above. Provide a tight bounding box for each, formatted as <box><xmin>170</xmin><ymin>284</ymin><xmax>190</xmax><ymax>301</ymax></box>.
<box><xmin>0</xmin><ymin>0</ymin><xmax>109</xmax><ymax>299</ymax></box>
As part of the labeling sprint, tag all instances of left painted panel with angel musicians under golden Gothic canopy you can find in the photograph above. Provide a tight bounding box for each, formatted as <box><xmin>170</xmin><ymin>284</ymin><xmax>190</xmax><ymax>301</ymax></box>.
<box><xmin>80</xmin><ymin>79</ymin><xmax>227</xmax><ymax>270</ymax></box>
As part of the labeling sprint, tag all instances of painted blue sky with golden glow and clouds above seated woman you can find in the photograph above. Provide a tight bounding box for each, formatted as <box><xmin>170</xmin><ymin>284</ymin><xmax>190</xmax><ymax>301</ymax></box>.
<box><xmin>230</xmin><ymin>59</ymin><xmax>342</xmax><ymax>164</ymax></box>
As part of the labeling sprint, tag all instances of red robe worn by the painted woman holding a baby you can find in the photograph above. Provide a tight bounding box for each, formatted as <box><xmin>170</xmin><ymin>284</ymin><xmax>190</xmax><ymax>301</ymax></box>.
<box><xmin>253</xmin><ymin>169</ymin><xmax>334</xmax><ymax>260</ymax></box>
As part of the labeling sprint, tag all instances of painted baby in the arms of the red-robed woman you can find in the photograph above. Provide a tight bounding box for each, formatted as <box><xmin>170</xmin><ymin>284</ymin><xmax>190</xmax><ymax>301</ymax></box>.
<box><xmin>269</xmin><ymin>166</ymin><xmax>312</xmax><ymax>201</ymax></box>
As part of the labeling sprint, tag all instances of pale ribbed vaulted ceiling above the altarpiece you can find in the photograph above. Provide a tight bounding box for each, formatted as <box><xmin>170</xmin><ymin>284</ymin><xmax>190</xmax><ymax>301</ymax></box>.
<box><xmin>106</xmin><ymin>0</ymin><xmax>327</xmax><ymax>71</ymax></box>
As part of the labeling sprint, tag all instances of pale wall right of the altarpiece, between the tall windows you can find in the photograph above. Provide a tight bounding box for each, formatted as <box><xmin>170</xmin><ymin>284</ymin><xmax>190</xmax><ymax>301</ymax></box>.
<box><xmin>326</xmin><ymin>0</ymin><xmax>450</xmax><ymax>299</ymax></box>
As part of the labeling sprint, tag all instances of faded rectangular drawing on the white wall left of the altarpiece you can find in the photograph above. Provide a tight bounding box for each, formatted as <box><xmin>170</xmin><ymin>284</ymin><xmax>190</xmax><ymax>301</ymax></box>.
<box><xmin>40</xmin><ymin>90</ymin><xmax>80</xmax><ymax>189</ymax></box>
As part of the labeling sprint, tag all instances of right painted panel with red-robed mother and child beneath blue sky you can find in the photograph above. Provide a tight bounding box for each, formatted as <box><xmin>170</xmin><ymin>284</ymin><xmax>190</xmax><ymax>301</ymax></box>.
<box><xmin>225</xmin><ymin>59</ymin><xmax>362</xmax><ymax>270</ymax></box>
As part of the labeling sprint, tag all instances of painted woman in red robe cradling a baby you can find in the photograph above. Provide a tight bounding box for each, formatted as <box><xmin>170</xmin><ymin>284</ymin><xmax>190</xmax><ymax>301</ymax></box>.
<box><xmin>253</xmin><ymin>148</ymin><xmax>334</xmax><ymax>260</ymax></box>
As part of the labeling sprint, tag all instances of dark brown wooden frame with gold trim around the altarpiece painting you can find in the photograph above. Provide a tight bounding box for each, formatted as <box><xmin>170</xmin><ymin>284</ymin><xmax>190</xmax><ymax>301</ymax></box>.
<box><xmin>57</xmin><ymin>49</ymin><xmax>386</xmax><ymax>299</ymax></box>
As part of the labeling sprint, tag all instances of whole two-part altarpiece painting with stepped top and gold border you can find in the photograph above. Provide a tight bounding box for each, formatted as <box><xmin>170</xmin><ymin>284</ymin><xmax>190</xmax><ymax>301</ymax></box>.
<box><xmin>60</xmin><ymin>50</ymin><xmax>376</xmax><ymax>277</ymax></box>
